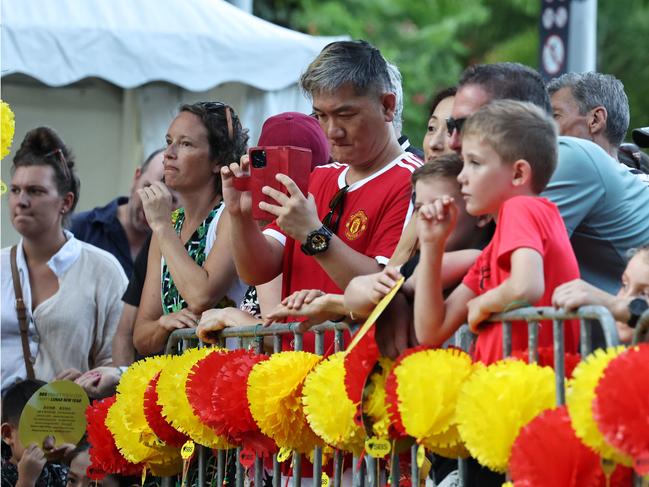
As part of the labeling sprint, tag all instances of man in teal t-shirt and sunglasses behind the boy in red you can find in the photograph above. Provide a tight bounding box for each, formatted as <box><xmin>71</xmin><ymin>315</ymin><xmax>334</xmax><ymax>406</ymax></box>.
<box><xmin>447</xmin><ymin>63</ymin><xmax>649</xmax><ymax>306</ymax></box>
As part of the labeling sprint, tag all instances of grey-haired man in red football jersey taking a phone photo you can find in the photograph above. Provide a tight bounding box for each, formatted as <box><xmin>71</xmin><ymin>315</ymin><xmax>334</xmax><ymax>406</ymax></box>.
<box><xmin>222</xmin><ymin>41</ymin><xmax>422</xmax><ymax>349</ymax></box>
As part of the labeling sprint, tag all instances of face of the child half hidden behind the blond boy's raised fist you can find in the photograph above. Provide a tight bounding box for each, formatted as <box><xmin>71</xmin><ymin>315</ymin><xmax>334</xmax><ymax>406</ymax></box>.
<box><xmin>415</xmin><ymin>176</ymin><xmax>477</xmax><ymax>251</ymax></box>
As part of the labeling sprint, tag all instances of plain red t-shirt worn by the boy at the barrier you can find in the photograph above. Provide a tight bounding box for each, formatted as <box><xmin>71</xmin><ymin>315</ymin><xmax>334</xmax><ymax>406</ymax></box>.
<box><xmin>462</xmin><ymin>196</ymin><xmax>579</xmax><ymax>364</ymax></box>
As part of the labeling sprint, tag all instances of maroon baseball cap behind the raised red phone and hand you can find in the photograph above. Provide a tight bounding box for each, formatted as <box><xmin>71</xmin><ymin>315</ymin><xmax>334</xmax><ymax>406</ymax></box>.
<box><xmin>257</xmin><ymin>112</ymin><xmax>330</xmax><ymax>168</ymax></box>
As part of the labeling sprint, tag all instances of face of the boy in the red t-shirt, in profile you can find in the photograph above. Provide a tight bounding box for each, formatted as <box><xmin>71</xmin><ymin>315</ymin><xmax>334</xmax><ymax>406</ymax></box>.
<box><xmin>457</xmin><ymin>136</ymin><xmax>513</xmax><ymax>217</ymax></box>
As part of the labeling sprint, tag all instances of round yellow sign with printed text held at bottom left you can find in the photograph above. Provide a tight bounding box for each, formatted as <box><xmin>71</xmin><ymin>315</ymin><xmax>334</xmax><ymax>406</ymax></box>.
<box><xmin>18</xmin><ymin>380</ymin><xmax>88</xmax><ymax>446</ymax></box>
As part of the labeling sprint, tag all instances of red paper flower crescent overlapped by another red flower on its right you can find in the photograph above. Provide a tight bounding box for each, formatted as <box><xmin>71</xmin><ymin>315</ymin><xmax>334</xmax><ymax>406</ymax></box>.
<box><xmin>185</xmin><ymin>350</ymin><xmax>236</xmax><ymax>428</ymax></box>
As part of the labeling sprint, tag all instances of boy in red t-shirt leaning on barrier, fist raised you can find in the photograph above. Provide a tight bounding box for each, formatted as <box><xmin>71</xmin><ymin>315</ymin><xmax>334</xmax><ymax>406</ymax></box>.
<box><xmin>415</xmin><ymin>100</ymin><xmax>579</xmax><ymax>364</ymax></box>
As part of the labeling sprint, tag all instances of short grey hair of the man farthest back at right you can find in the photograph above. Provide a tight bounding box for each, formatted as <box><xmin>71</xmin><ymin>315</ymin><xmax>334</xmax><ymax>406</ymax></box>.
<box><xmin>548</xmin><ymin>72</ymin><xmax>629</xmax><ymax>147</ymax></box>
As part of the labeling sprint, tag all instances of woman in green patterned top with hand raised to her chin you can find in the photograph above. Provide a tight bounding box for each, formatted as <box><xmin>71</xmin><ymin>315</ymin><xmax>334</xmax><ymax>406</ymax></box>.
<box><xmin>133</xmin><ymin>102</ymin><xmax>248</xmax><ymax>355</ymax></box>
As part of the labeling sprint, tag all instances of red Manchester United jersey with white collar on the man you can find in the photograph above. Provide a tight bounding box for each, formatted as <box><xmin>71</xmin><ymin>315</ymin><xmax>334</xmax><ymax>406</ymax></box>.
<box><xmin>264</xmin><ymin>152</ymin><xmax>423</xmax><ymax>351</ymax></box>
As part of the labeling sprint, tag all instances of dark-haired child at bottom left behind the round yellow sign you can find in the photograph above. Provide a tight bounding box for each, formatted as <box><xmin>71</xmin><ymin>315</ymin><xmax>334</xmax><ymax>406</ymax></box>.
<box><xmin>2</xmin><ymin>379</ymin><xmax>71</xmax><ymax>487</ymax></box>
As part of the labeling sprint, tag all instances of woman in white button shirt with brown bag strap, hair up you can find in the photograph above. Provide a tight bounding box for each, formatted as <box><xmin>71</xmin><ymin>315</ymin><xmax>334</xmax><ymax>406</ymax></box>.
<box><xmin>2</xmin><ymin>127</ymin><xmax>127</xmax><ymax>391</ymax></box>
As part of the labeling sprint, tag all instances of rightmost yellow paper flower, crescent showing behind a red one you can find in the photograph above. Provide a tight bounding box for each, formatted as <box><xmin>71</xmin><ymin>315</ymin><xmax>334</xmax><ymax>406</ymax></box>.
<box><xmin>566</xmin><ymin>347</ymin><xmax>633</xmax><ymax>466</ymax></box>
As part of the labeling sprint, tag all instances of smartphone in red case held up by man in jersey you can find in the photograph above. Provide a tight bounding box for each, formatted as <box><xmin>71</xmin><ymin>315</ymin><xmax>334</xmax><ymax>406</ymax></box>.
<box><xmin>238</xmin><ymin>146</ymin><xmax>312</xmax><ymax>221</ymax></box>
